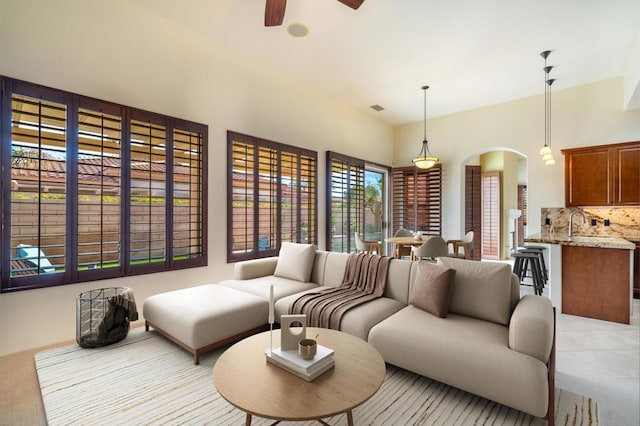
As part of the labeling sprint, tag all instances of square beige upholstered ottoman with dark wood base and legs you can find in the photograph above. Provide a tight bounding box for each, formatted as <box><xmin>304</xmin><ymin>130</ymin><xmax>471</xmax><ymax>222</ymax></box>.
<box><xmin>142</xmin><ymin>284</ymin><xmax>269</xmax><ymax>364</ymax></box>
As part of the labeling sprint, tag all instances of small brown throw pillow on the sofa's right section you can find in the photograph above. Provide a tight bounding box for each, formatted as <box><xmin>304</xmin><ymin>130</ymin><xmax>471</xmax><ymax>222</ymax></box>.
<box><xmin>409</xmin><ymin>261</ymin><xmax>456</xmax><ymax>318</ymax></box>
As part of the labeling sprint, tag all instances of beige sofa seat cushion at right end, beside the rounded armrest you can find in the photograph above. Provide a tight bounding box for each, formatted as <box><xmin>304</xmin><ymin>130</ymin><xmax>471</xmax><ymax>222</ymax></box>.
<box><xmin>368</xmin><ymin>304</ymin><xmax>548</xmax><ymax>417</ymax></box>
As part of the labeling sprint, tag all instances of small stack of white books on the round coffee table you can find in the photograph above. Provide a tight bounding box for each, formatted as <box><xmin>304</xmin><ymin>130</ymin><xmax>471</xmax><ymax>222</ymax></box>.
<box><xmin>264</xmin><ymin>345</ymin><xmax>335</xmax><ymax>382</ymax></box>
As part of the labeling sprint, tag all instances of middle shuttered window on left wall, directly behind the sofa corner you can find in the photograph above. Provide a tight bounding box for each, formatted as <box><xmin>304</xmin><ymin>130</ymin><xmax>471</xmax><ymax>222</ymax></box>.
<box><xmin>227</xmin><ymin>131</ymin><xmax>318</xmax><ymax>262</ymax></box>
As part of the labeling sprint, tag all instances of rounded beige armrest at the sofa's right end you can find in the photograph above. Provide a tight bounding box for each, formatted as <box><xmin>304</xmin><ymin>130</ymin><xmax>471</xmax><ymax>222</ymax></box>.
<box><xmin>509</xmin><ymin>294</ymin><xmax>555</xmax><ymax>363</ymax></box>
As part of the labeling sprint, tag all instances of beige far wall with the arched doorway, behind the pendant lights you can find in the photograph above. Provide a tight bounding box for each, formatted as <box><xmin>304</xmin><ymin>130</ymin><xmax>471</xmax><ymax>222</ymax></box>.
<box><xmin>393</xmin><ymin>78</ymin><xmax>640</xmax><ymax>243</ymax></box>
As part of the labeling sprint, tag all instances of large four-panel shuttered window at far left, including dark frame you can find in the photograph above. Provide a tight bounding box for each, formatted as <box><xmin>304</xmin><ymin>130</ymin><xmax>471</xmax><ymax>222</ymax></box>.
<box><xmin>0</xmin><ymin>77</ymin><xmax>208</xmax><ymax>291</ymax></box>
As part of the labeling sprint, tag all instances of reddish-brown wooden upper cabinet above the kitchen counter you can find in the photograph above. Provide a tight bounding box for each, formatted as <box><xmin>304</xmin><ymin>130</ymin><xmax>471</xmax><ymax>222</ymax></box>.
<box><xmin>562</xmin><ymin>141</ymin><xmax>640</xmax><ymax>207</ymax></box>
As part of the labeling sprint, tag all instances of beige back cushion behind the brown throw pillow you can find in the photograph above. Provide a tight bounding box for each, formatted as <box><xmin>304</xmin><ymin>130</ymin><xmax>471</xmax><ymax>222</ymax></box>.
<box><xmin>438</xmin><ymin>257</ymin><xmax>511</xmax><ymax>325</ymax></box>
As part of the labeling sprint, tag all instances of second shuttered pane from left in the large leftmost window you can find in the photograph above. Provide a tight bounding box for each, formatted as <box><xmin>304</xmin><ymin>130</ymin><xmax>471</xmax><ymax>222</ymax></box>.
<box><xmin>77</xmin><ymin>108</ymin><xmax>122</xmax><ymax>270</ymax></box>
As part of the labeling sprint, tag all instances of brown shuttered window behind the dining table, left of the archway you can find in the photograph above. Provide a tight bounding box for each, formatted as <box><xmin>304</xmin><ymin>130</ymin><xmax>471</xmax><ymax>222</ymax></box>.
<box><xmin>392</xmin><ymin>164</ymin><xmax>442</xmax><ymax>236</ymax></box>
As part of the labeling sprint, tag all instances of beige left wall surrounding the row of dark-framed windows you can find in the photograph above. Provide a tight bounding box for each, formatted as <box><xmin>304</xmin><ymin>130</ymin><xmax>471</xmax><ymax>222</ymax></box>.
<box><xmin>0</xmin><ymin>0</ymin><xmax>393</xmax><ymax>355</ymax></box>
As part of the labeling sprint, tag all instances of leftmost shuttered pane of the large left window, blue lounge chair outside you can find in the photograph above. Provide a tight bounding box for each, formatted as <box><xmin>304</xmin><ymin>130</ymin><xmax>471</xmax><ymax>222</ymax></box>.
<box><xmin>11</xmin><ymin>94</ymin><xmax>67</xmax><ymax>276</ymax></box>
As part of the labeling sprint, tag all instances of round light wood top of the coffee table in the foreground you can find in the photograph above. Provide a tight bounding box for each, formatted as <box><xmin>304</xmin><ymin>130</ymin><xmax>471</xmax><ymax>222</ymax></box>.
<box><xmin>213</xmin><ymin>327</ymin><xmax>386</xmax><ymax>421</ymax></box>
